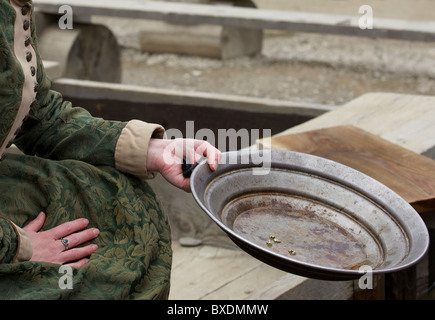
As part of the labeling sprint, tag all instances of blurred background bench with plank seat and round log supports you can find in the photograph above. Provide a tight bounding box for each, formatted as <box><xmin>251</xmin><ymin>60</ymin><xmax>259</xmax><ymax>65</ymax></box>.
<box><xmin>34</xmin><ymin>0</ymin><xmax>435</xmax><ymax>82</ymax></box>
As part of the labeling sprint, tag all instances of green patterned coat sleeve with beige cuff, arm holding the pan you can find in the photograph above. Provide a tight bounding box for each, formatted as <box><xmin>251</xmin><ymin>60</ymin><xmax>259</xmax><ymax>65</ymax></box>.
<box><xmin>14</xmin><ymin>5</ymin><xmax>164</xmax><ymax>178</ymax></box>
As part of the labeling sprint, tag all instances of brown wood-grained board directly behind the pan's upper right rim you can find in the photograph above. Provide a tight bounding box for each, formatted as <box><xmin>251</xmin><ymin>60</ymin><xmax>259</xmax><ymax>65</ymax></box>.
<box><xmin>271</xmin><ymin>125</ymin><xmax>435</xmax><ymax>212</ymax></box>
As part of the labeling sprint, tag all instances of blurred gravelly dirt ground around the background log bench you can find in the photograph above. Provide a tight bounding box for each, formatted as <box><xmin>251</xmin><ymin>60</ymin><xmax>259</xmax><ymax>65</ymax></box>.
<box><xmin>93</xmin><ymin>0</ymin><xmax>435</xmax><ymax>105</ymax></box>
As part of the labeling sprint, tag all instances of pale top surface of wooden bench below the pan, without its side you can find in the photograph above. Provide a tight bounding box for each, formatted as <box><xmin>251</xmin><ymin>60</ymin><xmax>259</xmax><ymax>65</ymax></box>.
<box><xmin>169</xmin><ymin>241</ymin><xmax>286</xmax><ymax>300</ymax></box>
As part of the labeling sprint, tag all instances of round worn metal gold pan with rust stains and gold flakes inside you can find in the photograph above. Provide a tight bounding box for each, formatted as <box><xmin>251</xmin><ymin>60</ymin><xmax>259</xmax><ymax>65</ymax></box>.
<box><xmin>191</xmin><ymin>150</ymin><xmax>429</xmax><ymax>280</ymax></box>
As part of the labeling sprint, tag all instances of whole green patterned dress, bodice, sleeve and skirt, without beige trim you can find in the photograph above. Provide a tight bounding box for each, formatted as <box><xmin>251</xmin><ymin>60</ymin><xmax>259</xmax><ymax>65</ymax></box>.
<box><xmin>0</xmin><ymin>0</ymin><xmax>172</xmax><ymax>299</ymax></box>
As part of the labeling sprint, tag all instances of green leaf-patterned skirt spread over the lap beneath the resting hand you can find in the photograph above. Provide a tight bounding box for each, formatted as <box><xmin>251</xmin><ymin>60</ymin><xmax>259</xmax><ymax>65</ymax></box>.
<box><xmin>0</xmin><ymin>154</ymin><xmax>171</xmax><ymax>299</ymax></box>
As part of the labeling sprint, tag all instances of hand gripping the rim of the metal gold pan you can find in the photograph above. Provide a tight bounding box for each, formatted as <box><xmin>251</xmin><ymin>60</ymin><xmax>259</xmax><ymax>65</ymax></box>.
<box><xmin>147</xmin><ymin>139</ymin><xmax>222</xmax><ymax>192</ymax></box>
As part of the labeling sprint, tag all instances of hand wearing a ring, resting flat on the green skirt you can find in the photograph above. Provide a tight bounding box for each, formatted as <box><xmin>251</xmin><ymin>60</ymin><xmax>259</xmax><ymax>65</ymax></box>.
<box><xmin>23</xmin><ymin>212</ymin><xmax>99</xmax><ymax>268</ymax></box>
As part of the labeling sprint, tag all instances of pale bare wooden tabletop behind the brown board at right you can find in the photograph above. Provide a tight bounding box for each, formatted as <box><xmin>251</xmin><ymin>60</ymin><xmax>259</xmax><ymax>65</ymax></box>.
<box><xmin>259</xmin><ymin>93</ymin><xmax>435</xmax><ymax>154</ymax></box>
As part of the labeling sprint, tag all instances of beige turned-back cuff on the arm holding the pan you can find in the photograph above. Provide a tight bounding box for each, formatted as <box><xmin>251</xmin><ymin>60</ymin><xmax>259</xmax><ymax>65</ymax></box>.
<box><xmin>115</xmin><ymin>120</ymin><xmax>165</xmax><ymax>179</ymax></box>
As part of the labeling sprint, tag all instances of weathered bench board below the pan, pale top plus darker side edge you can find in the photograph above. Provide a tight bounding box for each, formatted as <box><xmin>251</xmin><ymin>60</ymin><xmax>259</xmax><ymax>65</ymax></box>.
<box><xmin>169</xmin><ymin>241</ymin><xmax>353</xmax><ymax>300</ymax></box>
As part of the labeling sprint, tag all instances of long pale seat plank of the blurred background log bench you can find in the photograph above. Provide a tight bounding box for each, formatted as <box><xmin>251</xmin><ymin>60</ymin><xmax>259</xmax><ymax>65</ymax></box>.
<box><xmin>34</xmin><ymin>0</ymin><xmax>435</xmax><ymax>41</ymax></box>
